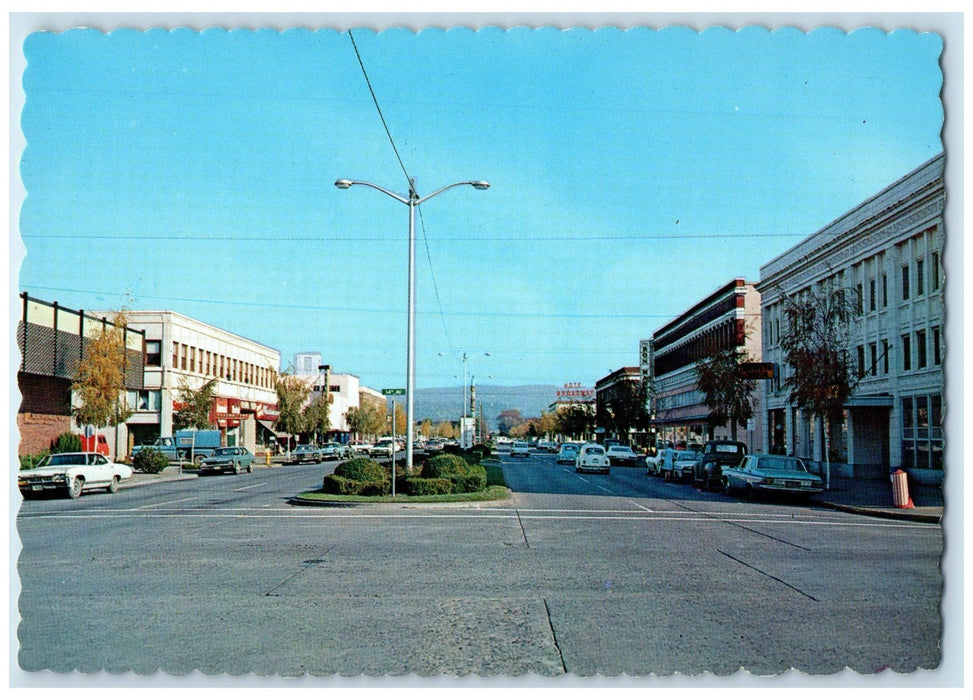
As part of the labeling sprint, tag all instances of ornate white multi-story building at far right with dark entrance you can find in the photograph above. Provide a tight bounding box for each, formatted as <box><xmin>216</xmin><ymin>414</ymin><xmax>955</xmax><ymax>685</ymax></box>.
<box><xmin>758</xmin><ymin>154</ymin><xmax>945</xmax><ymax>482</ymax></box>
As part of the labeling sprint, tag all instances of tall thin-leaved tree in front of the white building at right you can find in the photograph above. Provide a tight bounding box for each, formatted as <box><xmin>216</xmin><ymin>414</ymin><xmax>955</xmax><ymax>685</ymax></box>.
<box><xmin>780</xmin><ymin>288</ymin><xmax>860</xmax><ymax>488</ymax></box>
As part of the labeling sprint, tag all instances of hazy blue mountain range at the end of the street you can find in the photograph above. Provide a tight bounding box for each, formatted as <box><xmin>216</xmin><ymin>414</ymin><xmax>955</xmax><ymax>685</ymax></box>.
<box><xmin>398</xmin><ymin>384</ymin><xmax>561</xmax><ymax>427</ymax></box>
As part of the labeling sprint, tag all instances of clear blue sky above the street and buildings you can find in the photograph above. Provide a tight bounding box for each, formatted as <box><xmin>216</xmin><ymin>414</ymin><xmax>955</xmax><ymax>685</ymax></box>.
<box><xmin>14</xmin><ymin>27</ymin><xmax>943</xmax><ymax>388</ymax></box>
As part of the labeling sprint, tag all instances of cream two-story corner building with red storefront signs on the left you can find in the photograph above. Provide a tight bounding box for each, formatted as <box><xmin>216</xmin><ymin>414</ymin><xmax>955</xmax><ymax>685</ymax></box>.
<box><xmin>117</xmin><ymin>311</ymin><xmax>280</xmax><ymax>451</ymax></box>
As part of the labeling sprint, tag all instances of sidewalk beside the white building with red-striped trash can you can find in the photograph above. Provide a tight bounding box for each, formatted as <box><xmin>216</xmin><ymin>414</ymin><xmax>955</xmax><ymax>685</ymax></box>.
<box><xmin>811</xmin><ymin>477</ymin><xmax>944</xmax><ymax>523</ymax></box>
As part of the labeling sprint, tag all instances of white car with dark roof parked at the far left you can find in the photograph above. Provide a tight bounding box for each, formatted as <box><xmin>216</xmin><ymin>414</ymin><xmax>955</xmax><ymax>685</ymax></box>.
<box><xmin>17</xmin><ymin>452</ymin><xmax>132</xmax><ymax>498</ymax></box>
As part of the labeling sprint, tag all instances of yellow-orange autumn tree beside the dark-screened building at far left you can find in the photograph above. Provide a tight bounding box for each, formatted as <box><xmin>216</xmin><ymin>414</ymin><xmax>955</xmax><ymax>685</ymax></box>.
<box><xmin>71</xmin><ymin>312</ymin><xmax>132</xmax><ymax>428</ymax></box>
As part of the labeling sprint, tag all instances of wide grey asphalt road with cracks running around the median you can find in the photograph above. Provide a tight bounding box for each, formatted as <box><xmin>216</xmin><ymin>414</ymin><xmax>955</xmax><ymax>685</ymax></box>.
<box><xmin>17</xmin><ymin>453</ymin><xmax>943</xmax><ymax>682</ymax></box>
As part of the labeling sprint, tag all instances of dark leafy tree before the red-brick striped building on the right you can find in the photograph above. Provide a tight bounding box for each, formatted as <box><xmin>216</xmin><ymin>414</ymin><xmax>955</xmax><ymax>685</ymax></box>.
<box><xmin>696</xmin><ymin>347</ymin><xmax>757</xmax><ymax>440</ymax></box>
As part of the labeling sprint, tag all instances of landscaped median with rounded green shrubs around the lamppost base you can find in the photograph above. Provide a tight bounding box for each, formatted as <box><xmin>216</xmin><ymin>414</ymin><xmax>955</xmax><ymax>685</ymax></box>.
<box><xmin>291</xmin><ymin>448</ymin><xmax>510</xmax><ymax>505</ymax></box>
